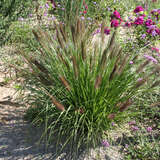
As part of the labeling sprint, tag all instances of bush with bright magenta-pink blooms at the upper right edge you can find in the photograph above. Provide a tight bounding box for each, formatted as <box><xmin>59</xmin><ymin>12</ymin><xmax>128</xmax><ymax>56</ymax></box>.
<box><xmin>121</xmin><ymin>6</ymin><xmax>160</xmax><ymax>48</ymax></box>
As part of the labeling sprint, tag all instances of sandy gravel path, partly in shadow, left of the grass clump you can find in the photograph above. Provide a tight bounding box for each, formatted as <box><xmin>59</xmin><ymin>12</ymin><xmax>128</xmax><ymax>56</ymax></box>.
<box><xmin>0</xmin><ymin>75</ymin><xmax>54</xmax><ymax>160</ymax></box>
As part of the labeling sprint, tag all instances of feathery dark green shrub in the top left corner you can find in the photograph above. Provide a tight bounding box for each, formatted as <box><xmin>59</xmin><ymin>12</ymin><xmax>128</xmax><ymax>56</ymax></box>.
<box><xmin>0</xmin><ymin>0</ymin><xmax>33</xmax><ymax>45</ymax></box>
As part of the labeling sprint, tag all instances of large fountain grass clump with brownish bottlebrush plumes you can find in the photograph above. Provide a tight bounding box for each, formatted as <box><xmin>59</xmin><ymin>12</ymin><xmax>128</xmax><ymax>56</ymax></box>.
<box><xmin>17</xmin><ymin>14</ymin><xmax>159</xmax><ymax>159</ymax></box>
